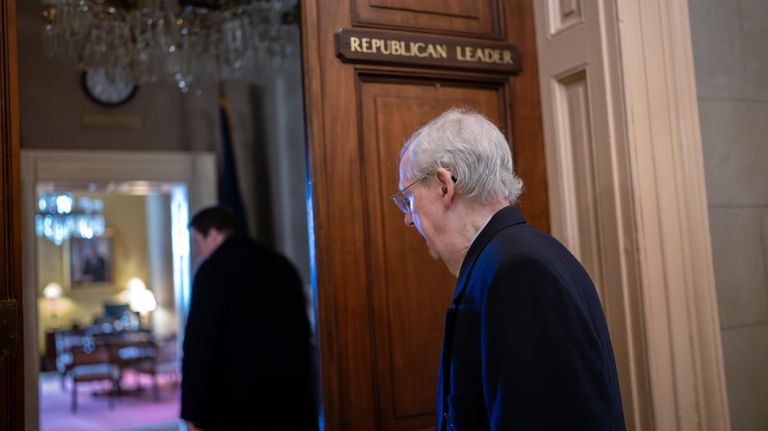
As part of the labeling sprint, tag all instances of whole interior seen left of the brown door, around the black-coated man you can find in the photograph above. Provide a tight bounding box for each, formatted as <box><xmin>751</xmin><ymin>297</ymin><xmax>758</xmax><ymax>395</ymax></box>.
<box><xmin>17</xmin><ymin>1</ymin><xmax>314</xmax><ymax>430</ymax></box>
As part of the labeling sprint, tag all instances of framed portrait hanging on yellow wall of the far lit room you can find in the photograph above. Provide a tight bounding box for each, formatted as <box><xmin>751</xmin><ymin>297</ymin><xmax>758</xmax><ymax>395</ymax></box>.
<box><xmin>69</xmin><ymin>235</ymin><xmax>114</xmax><ymax>288</ymax></box>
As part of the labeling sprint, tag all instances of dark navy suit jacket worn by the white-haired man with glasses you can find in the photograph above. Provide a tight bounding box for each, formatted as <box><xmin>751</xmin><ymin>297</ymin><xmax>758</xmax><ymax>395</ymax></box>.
<box><xmin>437</xmin><ymin>206</ymin><xmax>625</xmax><ymax>431</ymax></box>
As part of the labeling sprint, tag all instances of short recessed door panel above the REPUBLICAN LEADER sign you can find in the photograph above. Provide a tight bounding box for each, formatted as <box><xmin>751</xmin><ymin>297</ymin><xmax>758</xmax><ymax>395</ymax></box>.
<box><xmin>353</xmin><ymin>0</ymin><xmax>502</xmax><ymax>39</ymax></box>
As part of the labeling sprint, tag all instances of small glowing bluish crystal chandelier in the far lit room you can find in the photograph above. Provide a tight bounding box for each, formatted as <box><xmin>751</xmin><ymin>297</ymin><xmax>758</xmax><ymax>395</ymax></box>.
<box><xmin>35</xmin><ymin>193</ymin><xmax>105</xmax><ymax>245</ymax></box>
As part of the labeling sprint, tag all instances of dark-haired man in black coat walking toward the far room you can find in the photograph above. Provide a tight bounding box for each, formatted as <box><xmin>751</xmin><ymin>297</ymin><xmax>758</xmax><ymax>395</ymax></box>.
<box><xmin>181</xmin><ymin>207</ymin><xmax>315</xmax><ymax>431</ymax></box>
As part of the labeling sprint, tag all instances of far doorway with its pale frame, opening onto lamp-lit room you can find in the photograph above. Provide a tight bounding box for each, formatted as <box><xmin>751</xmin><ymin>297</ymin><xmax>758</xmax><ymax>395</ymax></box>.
<box><xmin>21</xmin><ymin>150</ymin><xmax>216</xmax><ymax>430</ymax></box>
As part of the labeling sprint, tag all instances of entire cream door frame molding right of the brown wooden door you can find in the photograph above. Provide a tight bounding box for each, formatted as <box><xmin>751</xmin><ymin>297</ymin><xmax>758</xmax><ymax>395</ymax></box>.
<box><xmin>534</xmin><ymin>0</ymin><xmax>730</xmax><ymax>430</ymax></box>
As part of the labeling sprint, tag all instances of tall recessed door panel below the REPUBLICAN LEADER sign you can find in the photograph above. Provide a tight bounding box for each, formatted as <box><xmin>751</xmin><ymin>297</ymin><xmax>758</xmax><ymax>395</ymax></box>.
<box><xmin>360</xmin><ymin>79</ymin><xmax>504</xmax><ymax>430</ymax></box>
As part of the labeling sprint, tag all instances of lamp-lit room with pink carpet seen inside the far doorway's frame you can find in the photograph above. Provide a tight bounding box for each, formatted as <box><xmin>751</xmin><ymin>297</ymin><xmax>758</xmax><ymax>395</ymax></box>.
<box><xmin>35</xmin><ymin>181</ymin><xmax>190</xmax><ymax>430</ymax></box>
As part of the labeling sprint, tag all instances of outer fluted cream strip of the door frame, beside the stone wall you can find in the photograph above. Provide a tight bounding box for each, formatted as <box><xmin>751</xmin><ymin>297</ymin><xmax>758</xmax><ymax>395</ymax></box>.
<box><xmin>617</xmin><ymin>0</ymin><xmax>730</xmax><ymax>430</ymax></box>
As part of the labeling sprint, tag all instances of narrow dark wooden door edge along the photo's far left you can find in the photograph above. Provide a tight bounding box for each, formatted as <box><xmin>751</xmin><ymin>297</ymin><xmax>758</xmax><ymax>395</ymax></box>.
<box><xmin>0</xmin><ymin>0</ymin><xmax>24</xmax><ymax>430</ymax></box>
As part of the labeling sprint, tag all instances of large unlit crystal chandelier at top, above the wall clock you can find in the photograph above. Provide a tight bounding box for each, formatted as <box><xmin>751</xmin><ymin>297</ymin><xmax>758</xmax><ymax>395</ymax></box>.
<box><xmin>42</xmin><ymin>0</ymin><xmax>298</xmax><ymax>92</ymax></box>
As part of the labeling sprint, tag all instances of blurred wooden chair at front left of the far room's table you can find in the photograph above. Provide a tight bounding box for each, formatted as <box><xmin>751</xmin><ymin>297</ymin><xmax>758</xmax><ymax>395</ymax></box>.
<box><xmin>68</xmin><ymin>343</ymin><xmax>120</xmax><ymax>413</ymax></box>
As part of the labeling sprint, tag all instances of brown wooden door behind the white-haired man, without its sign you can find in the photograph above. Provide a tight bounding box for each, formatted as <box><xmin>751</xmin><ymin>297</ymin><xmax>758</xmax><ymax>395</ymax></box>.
<box><xmin>302</xmin><ymin>0</ymin><xmax>549</xmax><ymax>430</ymax></box>
